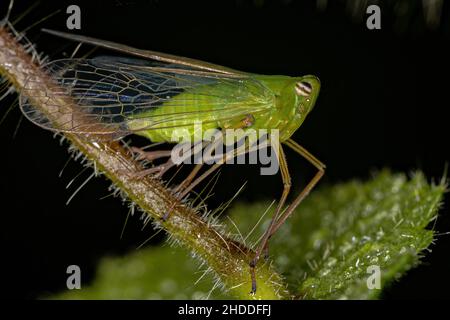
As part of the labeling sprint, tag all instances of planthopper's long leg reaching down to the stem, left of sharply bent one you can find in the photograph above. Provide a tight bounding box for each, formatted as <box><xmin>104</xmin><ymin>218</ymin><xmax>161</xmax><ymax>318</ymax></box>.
<box><xmin>250</xmin><ymin>145</ymin><xmax>291</xmax><ymax>293</ymax></box>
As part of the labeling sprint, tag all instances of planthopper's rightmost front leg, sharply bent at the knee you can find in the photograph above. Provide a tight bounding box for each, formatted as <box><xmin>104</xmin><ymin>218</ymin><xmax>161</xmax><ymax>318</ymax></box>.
<box><xmin>269</xmin><ymin>139</ymin><xmax>325</xmax><ymax>237</ymax></box>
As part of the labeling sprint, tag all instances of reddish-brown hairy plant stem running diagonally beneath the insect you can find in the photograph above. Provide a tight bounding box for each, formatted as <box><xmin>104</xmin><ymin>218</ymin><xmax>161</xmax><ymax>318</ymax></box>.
<box><xmin>0</xmin><ymin>25</ymin><xmax>289</xmax><ymax>299</ymax></box>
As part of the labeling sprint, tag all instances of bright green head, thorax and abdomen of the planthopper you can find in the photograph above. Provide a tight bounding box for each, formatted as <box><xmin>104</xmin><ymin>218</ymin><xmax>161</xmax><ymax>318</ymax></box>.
<box><xmin>128</xmin><ymin>75</ymin><xmax>320</xmax><ymax>142</ymax></box>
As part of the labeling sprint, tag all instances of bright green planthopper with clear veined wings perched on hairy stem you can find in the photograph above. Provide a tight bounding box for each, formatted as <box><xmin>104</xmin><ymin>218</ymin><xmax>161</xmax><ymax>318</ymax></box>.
<box><xmin>20</xmin><ymin>30</ymin><xmax>325</xmax><ymax>293</ymax></box>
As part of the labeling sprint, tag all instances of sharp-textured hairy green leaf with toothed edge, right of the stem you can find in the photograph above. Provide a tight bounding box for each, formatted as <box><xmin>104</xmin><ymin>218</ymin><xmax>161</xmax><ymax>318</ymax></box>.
<box><xmin>227</xmin><ymin>171</ymin><xmax>445</xmax><ymax>299</ymax></box>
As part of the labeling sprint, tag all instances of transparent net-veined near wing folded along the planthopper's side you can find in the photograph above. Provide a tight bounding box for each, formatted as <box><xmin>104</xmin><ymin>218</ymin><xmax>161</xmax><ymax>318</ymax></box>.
<box><xmin>20</xmin><ymin>57</ymin><xmax>273</xmax><ymax>134</ymax></box>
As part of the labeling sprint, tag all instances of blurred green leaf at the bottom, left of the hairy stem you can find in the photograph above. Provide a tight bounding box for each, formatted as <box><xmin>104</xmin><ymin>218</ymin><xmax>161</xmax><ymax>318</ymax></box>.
<box><xmin>50</xmin><ymin>246</ymin><xmax>231</xmax><ymax>300</ymax></box>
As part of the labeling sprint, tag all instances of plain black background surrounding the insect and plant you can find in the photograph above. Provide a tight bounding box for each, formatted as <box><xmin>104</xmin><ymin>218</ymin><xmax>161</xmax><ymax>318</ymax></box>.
<box><xmin>0</xmin><ymin>0</ymin><xmax>450</xmax><ymax>299</ymax></box>
